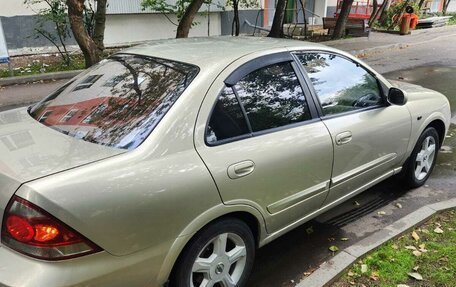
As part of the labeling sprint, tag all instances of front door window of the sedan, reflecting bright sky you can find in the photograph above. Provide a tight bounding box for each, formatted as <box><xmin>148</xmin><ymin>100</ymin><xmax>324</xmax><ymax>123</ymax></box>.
<box><xmin>297</xmin><ymin>53</ymin><xmax>383</xmax><ymax>116</ymax></box>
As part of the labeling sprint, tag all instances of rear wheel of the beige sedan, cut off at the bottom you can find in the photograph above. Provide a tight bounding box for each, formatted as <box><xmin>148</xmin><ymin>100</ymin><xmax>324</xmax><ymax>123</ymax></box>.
<box><xmin>169</xmin><ymin>218</ymin><xmax>255</xmax><ymax>287</ymax></box>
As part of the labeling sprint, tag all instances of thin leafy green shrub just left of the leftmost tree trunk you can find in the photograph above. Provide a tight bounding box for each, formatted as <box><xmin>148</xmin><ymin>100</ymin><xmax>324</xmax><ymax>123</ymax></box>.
<box><xmin>24</xmin><ymin>0</ymin><xmax>71</xmax><ymax>65</ymax></box>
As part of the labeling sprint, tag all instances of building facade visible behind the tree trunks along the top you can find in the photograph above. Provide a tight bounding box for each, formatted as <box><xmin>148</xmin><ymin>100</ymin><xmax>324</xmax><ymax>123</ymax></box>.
<box><xmin>0</xmin><ymin>0</ymin><xmax>456</xmax><ymax>49</ymax></box>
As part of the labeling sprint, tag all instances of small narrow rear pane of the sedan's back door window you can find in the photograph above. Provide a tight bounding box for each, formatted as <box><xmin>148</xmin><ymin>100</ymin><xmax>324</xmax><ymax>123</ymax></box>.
<box><xmin>206</xmin><ymin>85</ymin><xmax>249</xmax><ymax>144</ymax></box>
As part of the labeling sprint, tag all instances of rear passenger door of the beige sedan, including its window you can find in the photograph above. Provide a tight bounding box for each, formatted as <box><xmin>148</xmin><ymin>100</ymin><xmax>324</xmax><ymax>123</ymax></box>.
<box><xmin>195</xmin><ymin>53</ymin><xmax>333</xmax><ymax>232</ymax></box>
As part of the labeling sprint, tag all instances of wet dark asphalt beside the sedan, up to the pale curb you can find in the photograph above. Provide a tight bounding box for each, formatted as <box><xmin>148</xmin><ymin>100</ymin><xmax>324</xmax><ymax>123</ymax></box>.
<box><xmin>247</xmin><ymin>66</ymin><xmax>456</xmax><ymax>287</ymax></box>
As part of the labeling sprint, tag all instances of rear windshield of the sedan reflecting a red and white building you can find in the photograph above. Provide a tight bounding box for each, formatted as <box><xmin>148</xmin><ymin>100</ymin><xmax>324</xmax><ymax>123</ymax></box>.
<box><xmin>30</xmin><ymin>54</ymin><xmax>198</xmax><ymax>149</ymax></box>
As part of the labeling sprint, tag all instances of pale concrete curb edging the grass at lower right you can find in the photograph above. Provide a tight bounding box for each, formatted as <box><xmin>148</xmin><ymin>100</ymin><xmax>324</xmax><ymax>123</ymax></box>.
<box><xmin>295</xmin><ymin>198</ymin><xmax>456</xmax><ymax>287</ymax></box>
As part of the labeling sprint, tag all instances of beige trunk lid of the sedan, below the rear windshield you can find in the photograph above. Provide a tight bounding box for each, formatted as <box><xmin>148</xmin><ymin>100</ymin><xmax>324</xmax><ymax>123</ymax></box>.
<box><xmin>0</xmin><ymin>108</ymin><xmax>126</xmax><ymax>227</ymax></box>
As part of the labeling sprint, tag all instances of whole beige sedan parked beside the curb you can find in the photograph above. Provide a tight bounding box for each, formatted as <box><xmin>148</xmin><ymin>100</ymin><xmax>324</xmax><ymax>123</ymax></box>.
<box><xmin>0</xmin><ymin>37</ymin><xmax>450</xmax><ymax>287</ymax></box>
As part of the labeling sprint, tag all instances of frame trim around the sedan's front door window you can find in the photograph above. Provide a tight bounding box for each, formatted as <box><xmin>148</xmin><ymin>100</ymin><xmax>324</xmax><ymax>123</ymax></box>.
<box><xmin>291</xmin><ymin>49</ymin><xmax>388</xmax><ymax>119</ymax></box>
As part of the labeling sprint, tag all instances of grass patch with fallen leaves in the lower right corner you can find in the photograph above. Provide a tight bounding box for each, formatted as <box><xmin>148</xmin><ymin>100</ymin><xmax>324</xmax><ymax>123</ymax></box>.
<box><xmin>332</xmin><ymin>210</ymin><xmax>456</xmax><ymax>287</ymax></box>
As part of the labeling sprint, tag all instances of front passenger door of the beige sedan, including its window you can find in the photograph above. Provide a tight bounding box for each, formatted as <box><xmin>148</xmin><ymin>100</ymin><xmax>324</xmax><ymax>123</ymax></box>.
<box><xmin>296</xmin><ymin>52</ymin><xmax>411</xmax><ymax>205</ymax></box>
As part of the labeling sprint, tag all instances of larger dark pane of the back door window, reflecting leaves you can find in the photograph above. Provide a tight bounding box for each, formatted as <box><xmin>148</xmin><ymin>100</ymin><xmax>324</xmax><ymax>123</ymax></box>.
<box><xmin>234</xmin><ymin>62</ymin><xmax>311</xmax><ymax>132</ymax></box>
